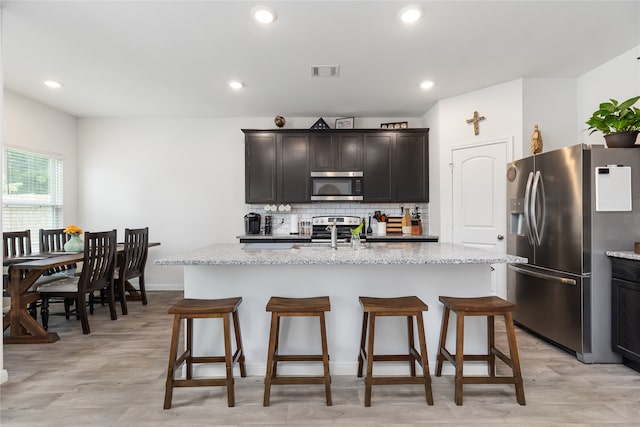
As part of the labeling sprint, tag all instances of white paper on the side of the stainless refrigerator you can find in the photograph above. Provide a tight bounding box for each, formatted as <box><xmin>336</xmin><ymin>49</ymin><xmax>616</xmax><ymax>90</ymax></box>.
<box><xmin>596</xmin><ymin>165</ymin><xmax>632</xmax><ymax>212</ymax></box>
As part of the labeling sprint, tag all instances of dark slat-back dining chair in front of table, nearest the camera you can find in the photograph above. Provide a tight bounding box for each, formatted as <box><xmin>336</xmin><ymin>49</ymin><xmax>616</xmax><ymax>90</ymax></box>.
<box><xmin>38</xmin><ymin>230</ymin><xmax>118</xmax><ymax>334</ymax></box>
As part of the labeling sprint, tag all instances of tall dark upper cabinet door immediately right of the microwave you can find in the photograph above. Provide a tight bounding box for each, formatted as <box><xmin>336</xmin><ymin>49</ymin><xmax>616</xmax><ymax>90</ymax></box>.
<box><xmin>364</xmin><ymin>133</ymin><xmax>394</xmax><ymax>202</ymax></box>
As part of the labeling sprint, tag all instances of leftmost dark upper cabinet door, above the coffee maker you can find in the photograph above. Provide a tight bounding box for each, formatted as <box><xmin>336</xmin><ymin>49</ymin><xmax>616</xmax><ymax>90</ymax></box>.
<box><xmin>244</xmin><ymin>133</ymin><xmax>277</xmax><ymax>203</ymax></box>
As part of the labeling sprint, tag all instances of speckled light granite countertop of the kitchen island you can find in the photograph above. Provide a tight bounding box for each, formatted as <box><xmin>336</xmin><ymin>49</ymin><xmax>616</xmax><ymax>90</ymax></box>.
<box><xmin>154</xmin><ymin>242</ymin><xmax>527</xmax><ymax>265</ymax></box>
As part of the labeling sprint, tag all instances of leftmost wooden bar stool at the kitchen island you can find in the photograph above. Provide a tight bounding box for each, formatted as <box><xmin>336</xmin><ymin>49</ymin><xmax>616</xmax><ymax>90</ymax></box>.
<box><xmin>164</xmin><ymin>297</ymin><xmax>247</xmax><ymax>409</ymax></box>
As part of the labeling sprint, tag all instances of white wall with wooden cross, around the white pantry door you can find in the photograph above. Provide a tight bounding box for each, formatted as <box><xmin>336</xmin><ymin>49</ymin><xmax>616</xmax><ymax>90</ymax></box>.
<box><xmin>425</xmin><ymin>80</ymin><xmax>523</xmax><ymax>242</ymax></box>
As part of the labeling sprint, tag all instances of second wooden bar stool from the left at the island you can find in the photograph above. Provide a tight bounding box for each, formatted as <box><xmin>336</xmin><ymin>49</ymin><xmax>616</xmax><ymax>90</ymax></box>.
<box><xmin>263</xmin><ymin>297</ymin><xmax>332</xmax><ymax>406</ymax></box>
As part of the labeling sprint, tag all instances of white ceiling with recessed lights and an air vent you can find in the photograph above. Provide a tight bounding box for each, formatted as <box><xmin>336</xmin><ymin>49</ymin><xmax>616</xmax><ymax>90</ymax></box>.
<box><xmin>1</xmin><ymin>0</ymin><xmax>640</xmax><ymax>117</ymax></box>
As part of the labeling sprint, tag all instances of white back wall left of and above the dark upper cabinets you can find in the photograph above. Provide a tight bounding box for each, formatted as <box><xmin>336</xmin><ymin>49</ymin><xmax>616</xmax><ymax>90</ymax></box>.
<box><xmin>78</xmin><ymin>117</ymin><xmax>422</xmax><ymax>289</ymax></box>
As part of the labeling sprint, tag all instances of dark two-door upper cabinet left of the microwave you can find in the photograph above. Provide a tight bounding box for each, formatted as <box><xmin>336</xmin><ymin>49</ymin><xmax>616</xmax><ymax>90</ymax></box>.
<box><xmin>245</xmin><ymin>131</ymin><xmax>309</xmax><ymax>204</ymax></box>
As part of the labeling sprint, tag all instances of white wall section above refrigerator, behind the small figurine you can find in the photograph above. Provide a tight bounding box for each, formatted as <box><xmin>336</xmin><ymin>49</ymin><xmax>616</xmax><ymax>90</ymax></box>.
<box><xmin>522</xmin><ymin>79</ymin><xmax>580</xmax><ymax>155</ymax></box>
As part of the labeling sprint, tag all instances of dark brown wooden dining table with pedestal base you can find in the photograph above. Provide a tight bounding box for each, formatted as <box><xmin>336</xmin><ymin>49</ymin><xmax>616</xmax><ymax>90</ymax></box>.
<box><xmin>3</xmin><ymin>242</ymin><xmax>160</xmax><ymax>344</ymax></box>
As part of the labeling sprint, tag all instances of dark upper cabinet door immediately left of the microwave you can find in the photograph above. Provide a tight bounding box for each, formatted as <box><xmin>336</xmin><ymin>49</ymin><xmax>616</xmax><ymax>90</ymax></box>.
<box><xmin>277</xmin><ymin>134</ymin><xmax>311</xmax><ymax>203</ymax></box>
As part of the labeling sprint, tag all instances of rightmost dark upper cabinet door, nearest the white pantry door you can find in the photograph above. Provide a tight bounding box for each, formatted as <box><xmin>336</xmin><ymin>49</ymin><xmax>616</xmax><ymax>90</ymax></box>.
<box><xmin>394</xmin><ymin>134</ymin><xmax>429</xmax><ymax>202</ymax></box>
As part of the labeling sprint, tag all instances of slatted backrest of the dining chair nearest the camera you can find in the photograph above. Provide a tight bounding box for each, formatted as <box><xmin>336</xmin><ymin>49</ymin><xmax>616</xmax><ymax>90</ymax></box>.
<box><xmin>78</xmin><ymin>230</ymin><xmax>117</xmax><ymax>293</ymax></box>
